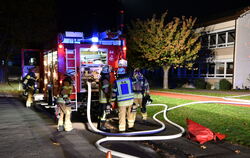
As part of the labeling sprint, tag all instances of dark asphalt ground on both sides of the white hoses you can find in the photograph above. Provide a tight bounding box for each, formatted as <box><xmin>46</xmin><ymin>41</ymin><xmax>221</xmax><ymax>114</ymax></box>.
<box><xmin>0</xmin><ymin>95</ymin><xmax>250</xmax><ymax>158</ymax></box>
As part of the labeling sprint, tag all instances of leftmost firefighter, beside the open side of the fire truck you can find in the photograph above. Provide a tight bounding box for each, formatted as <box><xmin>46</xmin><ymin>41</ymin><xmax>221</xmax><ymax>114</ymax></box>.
<box><xmin>23</xmin><ymin>67</ymin><xmax>37</xmax><ymax>107</ymax></box>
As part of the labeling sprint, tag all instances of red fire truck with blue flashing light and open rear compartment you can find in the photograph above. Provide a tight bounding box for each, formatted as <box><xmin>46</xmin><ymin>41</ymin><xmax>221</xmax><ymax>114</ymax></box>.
<box><xmin>27</xmin><ymin>31</ymin><xmax>127</xmax><ymax>113</ymax></box>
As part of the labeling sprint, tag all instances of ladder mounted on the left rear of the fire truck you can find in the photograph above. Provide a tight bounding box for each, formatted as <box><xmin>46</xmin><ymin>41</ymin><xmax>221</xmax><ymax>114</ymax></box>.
<box><xmin>65</xmin><ymin>49</ymin><xmax>77</xmax><ymax>111</ymax></box>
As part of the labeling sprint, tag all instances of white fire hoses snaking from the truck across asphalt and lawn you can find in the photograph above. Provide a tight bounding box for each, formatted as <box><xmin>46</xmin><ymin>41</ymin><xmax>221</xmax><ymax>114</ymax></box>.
<box><xmin>87</xmin><ymin>82</ymin><xmax>250</xmax><ymax>158</ymax></box>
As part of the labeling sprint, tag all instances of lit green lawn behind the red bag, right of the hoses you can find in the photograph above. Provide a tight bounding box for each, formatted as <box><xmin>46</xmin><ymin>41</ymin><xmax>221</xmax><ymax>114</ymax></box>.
<box><xmin>148</xmin><ymin>95</ymin><xmax>250</xmax><ymax>147</ymax></box>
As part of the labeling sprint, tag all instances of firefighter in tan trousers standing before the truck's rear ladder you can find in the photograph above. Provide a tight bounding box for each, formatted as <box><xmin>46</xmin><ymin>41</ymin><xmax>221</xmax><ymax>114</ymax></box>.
<box><xmin>57</xmin><ymin>74</ymin><xmax>73</xmax><ymax>132</ymax></box>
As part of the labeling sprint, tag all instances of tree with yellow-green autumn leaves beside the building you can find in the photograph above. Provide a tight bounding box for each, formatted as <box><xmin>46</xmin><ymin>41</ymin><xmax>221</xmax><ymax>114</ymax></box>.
<box><xmin>128</xmin><ymin>12</ymin><xmax>201</xmax><ymax>89</ymax></box>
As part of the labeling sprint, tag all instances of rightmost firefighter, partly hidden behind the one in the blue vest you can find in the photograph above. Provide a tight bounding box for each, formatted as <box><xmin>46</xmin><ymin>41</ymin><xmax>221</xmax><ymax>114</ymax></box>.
<box><xmin>132</xmin><ymin>68</ymin><xmax>150</xmax><ymax>122</ymax></box>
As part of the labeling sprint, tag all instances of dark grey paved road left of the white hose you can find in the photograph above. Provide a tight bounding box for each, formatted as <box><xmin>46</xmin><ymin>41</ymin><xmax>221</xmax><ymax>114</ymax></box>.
<box><xmin>0</xmin><ymin>97</ymin><xmax>106</xmax><ymax>158</ymax></box>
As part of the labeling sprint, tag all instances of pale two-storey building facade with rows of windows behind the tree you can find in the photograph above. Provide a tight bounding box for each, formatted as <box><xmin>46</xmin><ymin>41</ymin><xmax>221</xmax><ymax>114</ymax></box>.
<box><xmin>171</xmin><ymin>9</ymin><xmax>250</xmax><ymax>89</ymax></box>
